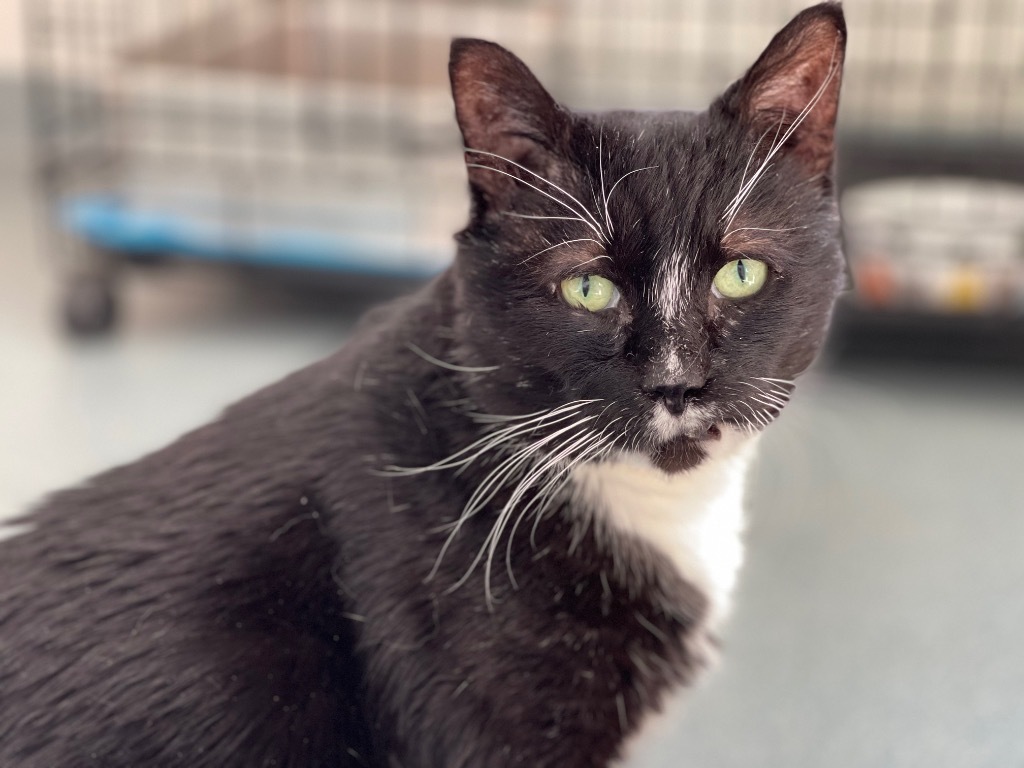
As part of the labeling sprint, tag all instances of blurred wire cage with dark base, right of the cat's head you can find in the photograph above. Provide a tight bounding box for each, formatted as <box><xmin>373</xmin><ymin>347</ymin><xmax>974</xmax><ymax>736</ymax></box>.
<box><xmin>834</xmin><ymin>0</ymin><xmax>1024</xmax><ymax>365</ymax></box>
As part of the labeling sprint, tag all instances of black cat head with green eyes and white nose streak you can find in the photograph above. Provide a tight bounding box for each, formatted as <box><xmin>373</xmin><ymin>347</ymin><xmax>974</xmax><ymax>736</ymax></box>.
<box><xmin>450</xmin><ymin>3</ymin><xmax>846</xmax><ymax>472</ymax></box>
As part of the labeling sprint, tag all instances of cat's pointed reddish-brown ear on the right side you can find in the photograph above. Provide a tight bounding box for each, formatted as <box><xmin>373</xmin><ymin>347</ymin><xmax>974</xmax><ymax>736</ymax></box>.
<box><xmin>734</xmin><ymin>2</ymin><xmax>846</xmax><ymax>180</ymax></box>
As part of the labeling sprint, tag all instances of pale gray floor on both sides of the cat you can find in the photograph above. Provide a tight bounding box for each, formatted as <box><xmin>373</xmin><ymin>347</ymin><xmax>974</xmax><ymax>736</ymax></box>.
<box><xmin>6</xmin><ymin>81</ymin><xmax>1024</xmax><ymax>768</ymax></box>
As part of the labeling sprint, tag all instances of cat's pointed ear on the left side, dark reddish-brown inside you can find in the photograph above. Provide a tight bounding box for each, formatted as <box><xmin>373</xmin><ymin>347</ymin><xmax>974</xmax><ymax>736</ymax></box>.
<box><xmin>449</xmin><ymin>38</ymin><xmax>569</xmax><ymax>207</ymax></box>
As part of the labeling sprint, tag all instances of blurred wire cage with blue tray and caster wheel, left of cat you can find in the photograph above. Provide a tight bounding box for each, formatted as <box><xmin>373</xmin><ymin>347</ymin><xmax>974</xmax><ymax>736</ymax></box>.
<box><xmin>26</xmin><ymin>0</ymin><xmax>569</xmax><ymax>330</ymax></box>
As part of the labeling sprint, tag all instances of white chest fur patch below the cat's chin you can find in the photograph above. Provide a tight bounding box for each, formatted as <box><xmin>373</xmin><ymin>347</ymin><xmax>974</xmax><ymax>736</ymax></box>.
<box><xmin>572</xmin><ymin>429</ymin><xmax>756</xmax><ymax>628</ymax></box>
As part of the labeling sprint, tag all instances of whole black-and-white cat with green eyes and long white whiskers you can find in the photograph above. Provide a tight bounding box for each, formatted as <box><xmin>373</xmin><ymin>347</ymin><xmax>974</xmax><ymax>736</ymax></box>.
<box><xmin>0</xmin><ymin>3</ymin><xmax>846</xmax><ymax>768</ymax></box>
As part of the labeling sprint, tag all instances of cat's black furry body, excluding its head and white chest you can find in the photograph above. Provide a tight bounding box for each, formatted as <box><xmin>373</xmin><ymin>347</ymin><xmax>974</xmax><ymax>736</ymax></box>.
<box><xmin>0</xmin><ymin>279</ymin><xmax>705</xmax><ymax>768</ymax></box>
